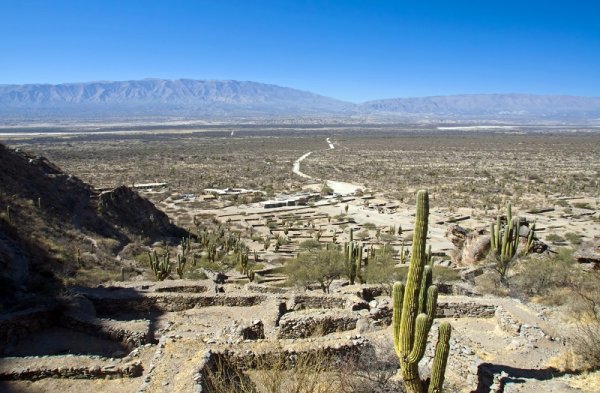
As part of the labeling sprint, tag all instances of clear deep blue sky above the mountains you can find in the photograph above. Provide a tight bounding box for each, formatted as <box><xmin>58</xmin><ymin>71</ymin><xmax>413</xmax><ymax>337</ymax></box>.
<box><xmin>0</xmin><ymin>0</ymin><xmax>600</xmax><ymax>102</ymax></box>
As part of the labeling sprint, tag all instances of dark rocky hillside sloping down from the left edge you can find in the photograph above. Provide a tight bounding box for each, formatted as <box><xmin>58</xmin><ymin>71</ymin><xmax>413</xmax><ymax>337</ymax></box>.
<box><xmin>0</xmin><ymin>144</ymin><xmax>186</xmax><ymax>308</ymax></box>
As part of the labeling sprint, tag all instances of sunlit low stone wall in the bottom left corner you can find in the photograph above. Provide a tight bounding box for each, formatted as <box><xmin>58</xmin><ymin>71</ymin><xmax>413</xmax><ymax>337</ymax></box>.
<box><xmin>0</xmin><ymin>355</ymin><xmax>143</xmax><ymax>381</ymax></box>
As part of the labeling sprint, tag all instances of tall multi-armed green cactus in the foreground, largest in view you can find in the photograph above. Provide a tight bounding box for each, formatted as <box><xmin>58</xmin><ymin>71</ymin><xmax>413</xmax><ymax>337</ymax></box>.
<box><xmin>392</xmin><ymin>190</ymin><xmax>452</xmax><ymax>393</ymax></box>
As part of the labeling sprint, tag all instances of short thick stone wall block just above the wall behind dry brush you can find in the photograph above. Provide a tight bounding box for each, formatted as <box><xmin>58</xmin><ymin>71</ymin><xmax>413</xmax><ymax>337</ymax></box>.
<box><xmin>278</xmin><ymin>311</ymin><xmax>359</xmax><ymax>338</ymax></box>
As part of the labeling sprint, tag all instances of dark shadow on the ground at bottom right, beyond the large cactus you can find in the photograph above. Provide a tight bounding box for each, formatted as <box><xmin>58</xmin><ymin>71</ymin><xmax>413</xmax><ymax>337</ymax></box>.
<box><xmin>471</xmin><ymin>363</ymin><xmax>569</xmax><ymax>393</ymax></box>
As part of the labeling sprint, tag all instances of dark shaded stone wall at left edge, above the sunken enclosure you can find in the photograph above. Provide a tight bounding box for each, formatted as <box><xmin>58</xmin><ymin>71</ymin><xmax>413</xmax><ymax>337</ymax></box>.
<box><xmin>0</xmin><ymin>307</ymin><xmax>58</xmax><ymax>355</ymax></box>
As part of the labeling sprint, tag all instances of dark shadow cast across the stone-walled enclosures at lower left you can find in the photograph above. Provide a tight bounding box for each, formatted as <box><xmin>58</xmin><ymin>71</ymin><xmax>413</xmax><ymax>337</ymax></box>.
<box><xmin>0</xmin><ymin>287</ymin><xmax>164</xmax><ymax>393</ymax></box>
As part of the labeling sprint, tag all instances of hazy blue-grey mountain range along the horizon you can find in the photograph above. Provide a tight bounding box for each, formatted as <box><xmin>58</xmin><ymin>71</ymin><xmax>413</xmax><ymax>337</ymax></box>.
<box><xmin>0</xmin><ymin>79</ymin><xmax>600</xmax><ymax>120</ymax></box>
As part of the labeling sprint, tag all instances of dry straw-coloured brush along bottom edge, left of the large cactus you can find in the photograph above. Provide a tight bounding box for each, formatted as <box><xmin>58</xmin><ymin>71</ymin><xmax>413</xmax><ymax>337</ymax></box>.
<box><xmin>200</xmin><ymin>340</ymin><xmax>405</xmax><ymax>393</ymax></box>
